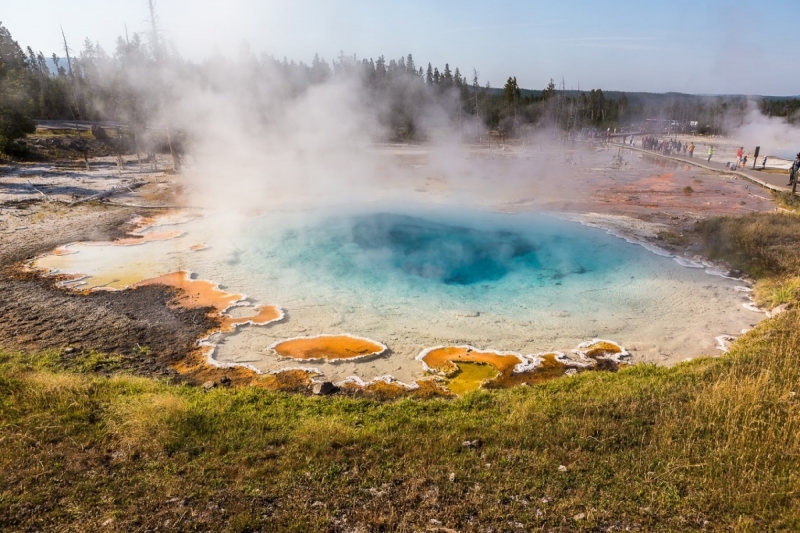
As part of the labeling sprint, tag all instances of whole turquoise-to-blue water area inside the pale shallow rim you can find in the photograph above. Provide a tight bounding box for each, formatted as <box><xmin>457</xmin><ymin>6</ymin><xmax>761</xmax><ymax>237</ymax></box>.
<box><xmin>247</xmin><ymin>210</ymin><xmax>620</xmax><ymax>305</ymax></box>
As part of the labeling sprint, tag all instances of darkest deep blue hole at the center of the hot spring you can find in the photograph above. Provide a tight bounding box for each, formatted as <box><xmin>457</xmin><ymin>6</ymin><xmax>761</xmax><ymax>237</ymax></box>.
<box><xmin>353</xmin><ymin>214</ymin><xmax>540</xmax><ymax>285</ymax></box>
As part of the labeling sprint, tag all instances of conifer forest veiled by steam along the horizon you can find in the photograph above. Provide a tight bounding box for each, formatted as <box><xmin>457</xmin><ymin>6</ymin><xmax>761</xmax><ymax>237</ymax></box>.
<box><xmin>0</xmin><ymin>23</ymin><xmax>800</xmax><ymax>156</ymax></box>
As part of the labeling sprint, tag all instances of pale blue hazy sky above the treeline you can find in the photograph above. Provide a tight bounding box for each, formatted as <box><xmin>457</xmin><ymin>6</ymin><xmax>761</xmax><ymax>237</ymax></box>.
<box><xmin>0</xmin><ymin>0</ymin><xmax>800</xmax><ymax>96</ymax></box>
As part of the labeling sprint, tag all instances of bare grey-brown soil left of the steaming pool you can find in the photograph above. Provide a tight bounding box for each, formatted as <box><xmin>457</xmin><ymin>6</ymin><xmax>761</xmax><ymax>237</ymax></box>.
<box><xmin>0</xmin><ymin>206</ymin><xmax>219</xmax><ymax>377</ymax></box>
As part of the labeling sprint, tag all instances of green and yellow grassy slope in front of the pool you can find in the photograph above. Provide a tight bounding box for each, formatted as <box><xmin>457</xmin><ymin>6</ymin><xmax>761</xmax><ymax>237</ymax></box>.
<box><xmin>0</xmin><ymin>211</ymin><xmax>800</xmax><ymax>531</ymax></box>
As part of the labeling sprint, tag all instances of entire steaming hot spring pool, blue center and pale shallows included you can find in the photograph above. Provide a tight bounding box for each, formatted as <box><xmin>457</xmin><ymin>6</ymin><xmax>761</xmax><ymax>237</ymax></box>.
<box><xmin>36</xmin><ymin>208</ymin><xmax>758</xmax><ymax>383</ymax></box>
